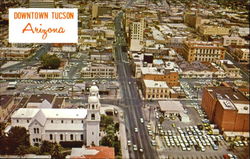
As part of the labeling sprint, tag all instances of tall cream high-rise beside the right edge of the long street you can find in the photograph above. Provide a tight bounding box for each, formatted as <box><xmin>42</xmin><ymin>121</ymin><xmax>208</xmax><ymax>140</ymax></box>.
<box><xmin>130</xmin><ymin>18</ymin><xmax>145</xmax><ymax>51</ymax></box>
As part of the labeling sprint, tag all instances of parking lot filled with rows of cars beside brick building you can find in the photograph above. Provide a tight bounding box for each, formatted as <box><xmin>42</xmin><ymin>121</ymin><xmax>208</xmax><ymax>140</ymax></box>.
<box><xmin>144</xmin><ymin>101</ymin><xmax>249</xmax><ymax>159</ymax></box>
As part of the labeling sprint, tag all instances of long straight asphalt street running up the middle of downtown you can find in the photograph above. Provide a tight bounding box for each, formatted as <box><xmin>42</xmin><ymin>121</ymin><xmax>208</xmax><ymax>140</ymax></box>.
<box><xmin>115</xmin><ymin>12</ymin><xmax>158</xmax><ymax>159</ymax></box>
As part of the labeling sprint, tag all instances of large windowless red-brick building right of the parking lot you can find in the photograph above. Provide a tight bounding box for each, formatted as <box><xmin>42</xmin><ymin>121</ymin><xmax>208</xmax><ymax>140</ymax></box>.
<box><xmin>202</xmin><ymin>86</ymin><xmax>249</xmax><ymax>132</ymax></box>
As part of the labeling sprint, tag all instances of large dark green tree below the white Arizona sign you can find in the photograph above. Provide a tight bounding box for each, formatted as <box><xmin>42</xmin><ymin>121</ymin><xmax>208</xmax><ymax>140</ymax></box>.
<box><xmin>41</xmin><ymin>54</ymin><xmax>61</xmax><ymax>69</ymax></box>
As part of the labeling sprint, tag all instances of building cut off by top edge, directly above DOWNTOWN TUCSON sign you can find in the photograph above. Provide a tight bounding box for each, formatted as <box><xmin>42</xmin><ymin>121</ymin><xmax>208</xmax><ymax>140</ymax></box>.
<box><xmin>29</xmin><ymin>0</ymin><xmax>55</xmax><ymax>8</ymax></box>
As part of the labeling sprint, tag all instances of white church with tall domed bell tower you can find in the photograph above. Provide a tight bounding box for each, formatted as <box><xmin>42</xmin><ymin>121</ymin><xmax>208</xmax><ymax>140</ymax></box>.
<box><xmin>8</xmin><ymin>86</ymin><xmax>100</xmax><ymax>146</ymax></box>
